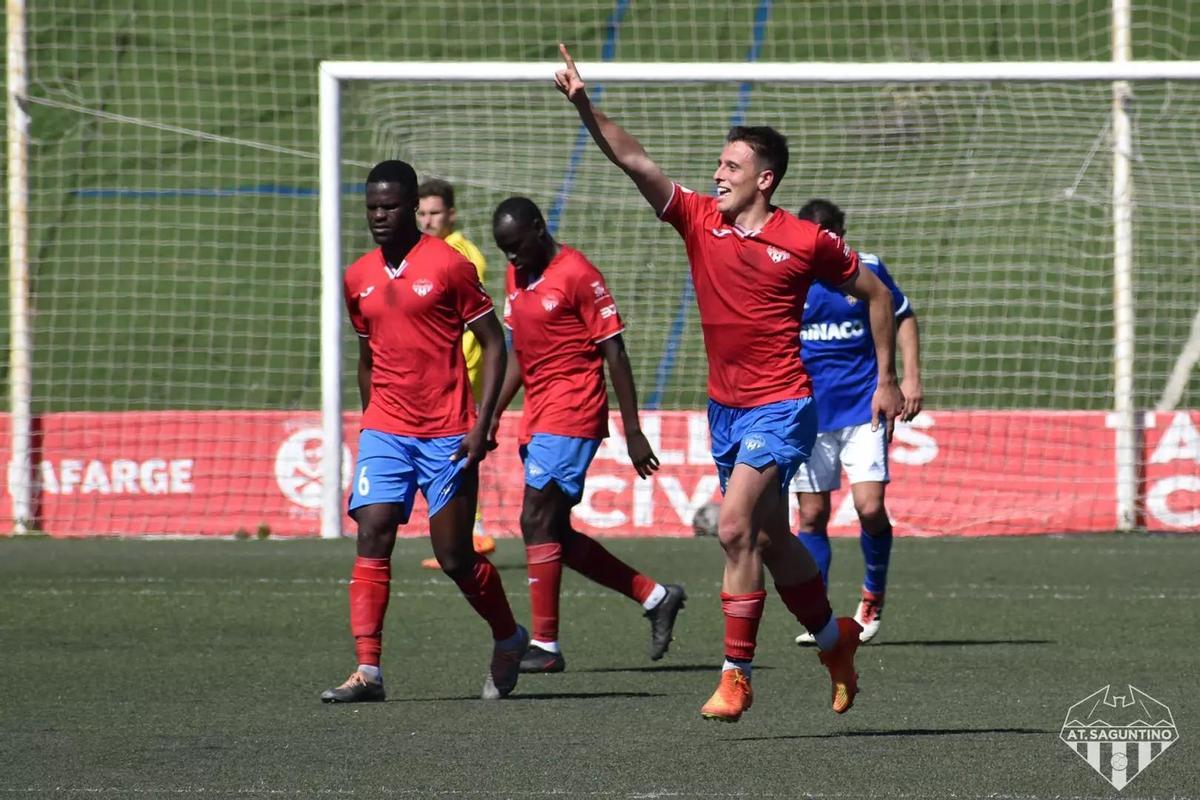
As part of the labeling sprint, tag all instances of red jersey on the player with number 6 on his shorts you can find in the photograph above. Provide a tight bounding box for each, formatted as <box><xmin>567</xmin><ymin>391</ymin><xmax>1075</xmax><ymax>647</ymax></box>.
<box><xmin>346</xmin><ymin>235</ymin><xmax>492</xmax><ymax>439</ymax></box>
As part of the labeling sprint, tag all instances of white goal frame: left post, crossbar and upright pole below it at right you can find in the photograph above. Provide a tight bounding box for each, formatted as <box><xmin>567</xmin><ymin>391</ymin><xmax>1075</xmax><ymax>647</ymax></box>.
<box><xmin>319</xmin><ymin>56</ymin><xmax>1200</xmax><ymax>537</ymax></box>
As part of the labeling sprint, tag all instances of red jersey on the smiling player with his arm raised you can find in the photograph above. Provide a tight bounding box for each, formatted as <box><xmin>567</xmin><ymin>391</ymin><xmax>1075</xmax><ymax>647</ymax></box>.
<box><xmin>659</xmin><ymin>184</ymin><xmax>858</xmax><ymax>408</ymax></box>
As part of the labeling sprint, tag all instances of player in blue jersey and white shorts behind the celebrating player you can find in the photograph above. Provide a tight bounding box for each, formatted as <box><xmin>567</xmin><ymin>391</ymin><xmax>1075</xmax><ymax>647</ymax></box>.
<box><xmin>792</xmin><ymin>200</ymin><xmax>924</xmax><ymax>644</ymax></box>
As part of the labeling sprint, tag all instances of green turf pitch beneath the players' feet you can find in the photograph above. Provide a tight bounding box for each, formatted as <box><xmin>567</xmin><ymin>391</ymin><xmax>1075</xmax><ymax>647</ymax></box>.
<box><xmin>0</xmin><ymin>535</ymin><xmax>1200</xmax><ymax>800</ymax></box>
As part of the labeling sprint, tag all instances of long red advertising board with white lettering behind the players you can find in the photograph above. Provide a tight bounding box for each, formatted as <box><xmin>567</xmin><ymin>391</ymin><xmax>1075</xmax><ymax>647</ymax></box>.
<box><xmin>0</xmin><ymin>411</ymin><xmax>1200</xmax><ymax>536</ymax></box>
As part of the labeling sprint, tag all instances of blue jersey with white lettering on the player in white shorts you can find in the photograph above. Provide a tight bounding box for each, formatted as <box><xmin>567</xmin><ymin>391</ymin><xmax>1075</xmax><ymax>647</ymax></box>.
<box><xmin>800</xmin><ymin>253</ymin><xmax>912</xmax><ymax>433</ymax></box>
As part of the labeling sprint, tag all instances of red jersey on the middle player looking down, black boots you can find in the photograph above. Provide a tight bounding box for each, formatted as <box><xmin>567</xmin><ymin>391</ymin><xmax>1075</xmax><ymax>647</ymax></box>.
<box><xmin>504</xmin><ymin>245</ymin><xmax>625</xmax><ymax>444</ymax></box>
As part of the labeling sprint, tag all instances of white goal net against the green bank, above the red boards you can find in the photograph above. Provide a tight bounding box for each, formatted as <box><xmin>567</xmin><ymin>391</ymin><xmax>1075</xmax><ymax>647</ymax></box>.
<box><xmin>341</xmin><ymin>71</ymin><xmax>1200</xmax><ymax>410</ymax></box>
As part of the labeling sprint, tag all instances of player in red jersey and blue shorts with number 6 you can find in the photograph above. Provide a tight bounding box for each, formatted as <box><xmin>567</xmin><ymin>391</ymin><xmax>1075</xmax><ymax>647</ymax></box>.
<box><xmin>320</xmin><ymin>161</ymin><xmax>529</xmax><ymax>703</ymax></box>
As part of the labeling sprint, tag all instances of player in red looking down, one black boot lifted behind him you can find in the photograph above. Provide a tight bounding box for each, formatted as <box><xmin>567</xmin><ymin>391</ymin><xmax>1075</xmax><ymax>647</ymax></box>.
<box><xmin>492</xmin><ymin>197</ymin><xmax>686</xmax><ymax>672</ymax></box>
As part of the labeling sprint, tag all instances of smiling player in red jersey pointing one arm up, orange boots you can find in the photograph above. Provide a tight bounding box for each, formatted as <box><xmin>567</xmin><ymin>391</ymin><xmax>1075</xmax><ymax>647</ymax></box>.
<box><xmin>554</xmin><ymin>46</ymin><xmax>902</xmax><ymax>722</ymax></box>
